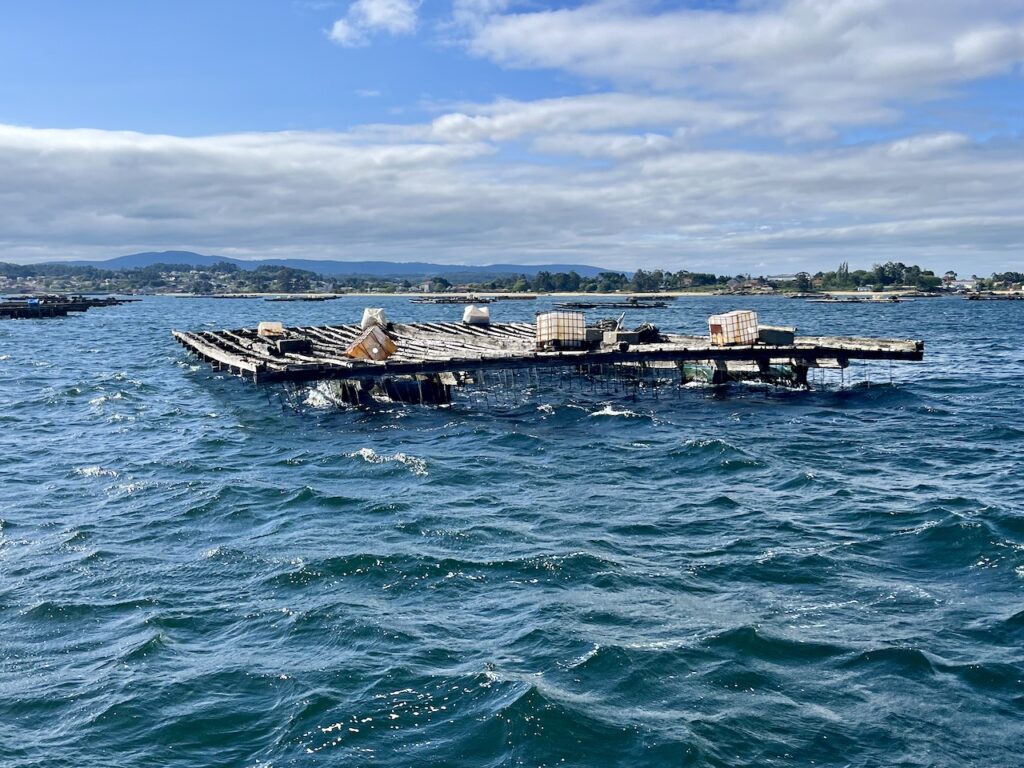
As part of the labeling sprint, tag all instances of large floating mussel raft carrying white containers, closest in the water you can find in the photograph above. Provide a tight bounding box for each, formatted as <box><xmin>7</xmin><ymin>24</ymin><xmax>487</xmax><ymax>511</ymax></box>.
<box><xmin>172</xmin><ymin>310</ymin><xmax>925</xmax><ymax>403</ymax></box>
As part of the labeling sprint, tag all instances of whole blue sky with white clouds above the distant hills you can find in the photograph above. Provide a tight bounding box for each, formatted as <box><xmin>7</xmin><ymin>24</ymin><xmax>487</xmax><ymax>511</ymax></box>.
<box><xmin>0</xmin><ymin>0</ymin><xmax>1024</xmax><ymax>274</ymax></box>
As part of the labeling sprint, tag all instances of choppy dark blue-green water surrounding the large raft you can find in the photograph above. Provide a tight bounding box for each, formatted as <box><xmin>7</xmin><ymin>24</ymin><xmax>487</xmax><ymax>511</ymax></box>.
<box><xmin>0</xmin><ymin>298</ymin><xmax>1024</xmax><ymax>768</ymax></box>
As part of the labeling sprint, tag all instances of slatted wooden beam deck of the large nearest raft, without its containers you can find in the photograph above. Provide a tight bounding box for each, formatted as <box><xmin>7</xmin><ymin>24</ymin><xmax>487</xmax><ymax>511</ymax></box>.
<box><xmin>172</xmin><ymin>323</ymin><xmax>925</xmax><ymax>383</ymax></box>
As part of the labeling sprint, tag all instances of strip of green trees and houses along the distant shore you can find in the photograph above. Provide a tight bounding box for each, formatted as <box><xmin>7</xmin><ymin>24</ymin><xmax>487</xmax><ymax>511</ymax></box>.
<box><xmin>0</xmin><ymin>261</ymin><xmax>1024</xmax><ymax>294</ymax></box>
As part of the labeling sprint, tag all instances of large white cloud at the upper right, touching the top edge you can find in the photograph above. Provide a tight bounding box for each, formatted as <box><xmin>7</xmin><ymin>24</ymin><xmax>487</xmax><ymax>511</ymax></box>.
<box><xmin>457</xmin><ymin>0</ymin><xmax>1024</xmax><ymax>138</ymax></box>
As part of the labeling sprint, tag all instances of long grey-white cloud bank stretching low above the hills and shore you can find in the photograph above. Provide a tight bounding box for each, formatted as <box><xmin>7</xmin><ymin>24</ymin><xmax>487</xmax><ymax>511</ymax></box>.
<box><xmin>0</xmin><ymin>123</ymin><xmax>1024</xmax><ymax>272</ymax></box>
